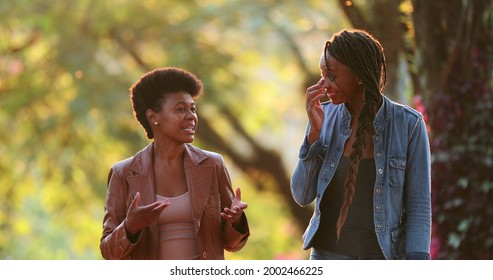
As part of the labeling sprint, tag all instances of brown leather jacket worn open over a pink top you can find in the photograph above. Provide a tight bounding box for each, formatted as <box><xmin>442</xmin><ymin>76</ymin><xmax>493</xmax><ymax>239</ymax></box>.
<box><xmin>100</xmin><ymin>143</ymin><xmax>250</xmax><ymax>260</ymax></box>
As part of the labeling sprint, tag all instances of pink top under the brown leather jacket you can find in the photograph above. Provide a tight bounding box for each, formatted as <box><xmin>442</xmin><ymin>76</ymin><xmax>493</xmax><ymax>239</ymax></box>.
<box><xmin>156</xmin><ymin>192</ymin><xmax>200</xmax><ymax>260</ymax></box>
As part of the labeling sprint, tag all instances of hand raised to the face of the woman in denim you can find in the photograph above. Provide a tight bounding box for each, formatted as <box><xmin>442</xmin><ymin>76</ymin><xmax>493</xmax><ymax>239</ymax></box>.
<box><xmin>305</xmin><ymin>78</ymin><xmax>326</xmax><ymax>144</ymax></box>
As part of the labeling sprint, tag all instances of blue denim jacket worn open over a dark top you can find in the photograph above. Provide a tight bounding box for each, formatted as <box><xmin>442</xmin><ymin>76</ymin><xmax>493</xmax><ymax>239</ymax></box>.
<box><xmin>291</xmin><ymin>96</ymin><xmax>431</xmax><ymax>259</ymax></box>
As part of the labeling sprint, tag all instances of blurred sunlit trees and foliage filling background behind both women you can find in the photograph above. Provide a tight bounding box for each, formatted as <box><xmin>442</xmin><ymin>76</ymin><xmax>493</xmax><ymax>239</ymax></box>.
<box><xmin>0</xmin><ymin>0</ymin><xmax>493</xmax><ymax>259</ymax></box>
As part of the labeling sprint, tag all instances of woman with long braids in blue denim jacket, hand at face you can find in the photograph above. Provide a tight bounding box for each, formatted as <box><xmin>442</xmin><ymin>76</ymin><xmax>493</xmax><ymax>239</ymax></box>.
<box><xmin>291</xmin><ymin>30</ymin><xmax>431</xmax><ymax>260</ymax></box>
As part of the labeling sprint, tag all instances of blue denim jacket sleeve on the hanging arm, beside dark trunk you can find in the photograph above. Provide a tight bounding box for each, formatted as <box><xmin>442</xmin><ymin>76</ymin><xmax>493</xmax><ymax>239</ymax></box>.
<box><xmin>405</xmin><ymin>116</ymin><xmax>431</xmax><ymax>259</ymax></box>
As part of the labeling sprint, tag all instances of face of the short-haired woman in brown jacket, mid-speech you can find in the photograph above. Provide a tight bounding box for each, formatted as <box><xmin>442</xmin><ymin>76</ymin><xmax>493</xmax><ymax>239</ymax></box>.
<box><xmin>150</xmin><ymin>91</ymin><xmax>199</xmax><ymax>144</ymax></box>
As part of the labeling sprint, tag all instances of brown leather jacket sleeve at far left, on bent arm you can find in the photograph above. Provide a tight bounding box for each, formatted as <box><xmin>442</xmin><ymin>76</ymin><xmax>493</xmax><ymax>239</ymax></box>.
<box><xmin>99</xmin><ymin>167</ymin><xmax>142</xmax><ymax>259</ymax></box>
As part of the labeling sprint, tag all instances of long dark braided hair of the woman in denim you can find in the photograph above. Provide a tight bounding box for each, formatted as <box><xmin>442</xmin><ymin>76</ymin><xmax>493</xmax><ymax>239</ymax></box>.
<box><xmin>324</xmin><ymin>30</ymin><xmax>387</xmax><ymax>240</ymax></box>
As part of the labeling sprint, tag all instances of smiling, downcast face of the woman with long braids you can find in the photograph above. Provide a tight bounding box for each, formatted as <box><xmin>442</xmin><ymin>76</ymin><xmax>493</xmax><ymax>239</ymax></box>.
<box><xmin>320</xmin><ymin>54</ymin><xmax>364</xmax><ymax>104</ymax></box>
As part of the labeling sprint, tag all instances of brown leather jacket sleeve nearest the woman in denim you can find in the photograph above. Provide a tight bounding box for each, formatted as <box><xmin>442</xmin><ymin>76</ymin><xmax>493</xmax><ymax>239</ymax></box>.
<box><xmin>218</xmin><ymin>157</ymin><xmax>250</xmax><ymax>252</ymax></box>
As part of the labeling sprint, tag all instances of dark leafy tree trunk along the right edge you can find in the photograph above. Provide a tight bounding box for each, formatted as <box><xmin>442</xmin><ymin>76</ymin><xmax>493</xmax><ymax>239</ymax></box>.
<box><xmin>412</xmin><ymin>0</ymin><xmax>493</xmax><ymax>259</ymax></box>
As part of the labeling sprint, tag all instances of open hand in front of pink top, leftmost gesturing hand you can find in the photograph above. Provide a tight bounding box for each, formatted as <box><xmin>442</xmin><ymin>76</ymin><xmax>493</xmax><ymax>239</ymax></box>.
<box><xmin>125</xmin><ymin>192</ymin><xmax>169</xmax><ymax>236</ymax></box>
